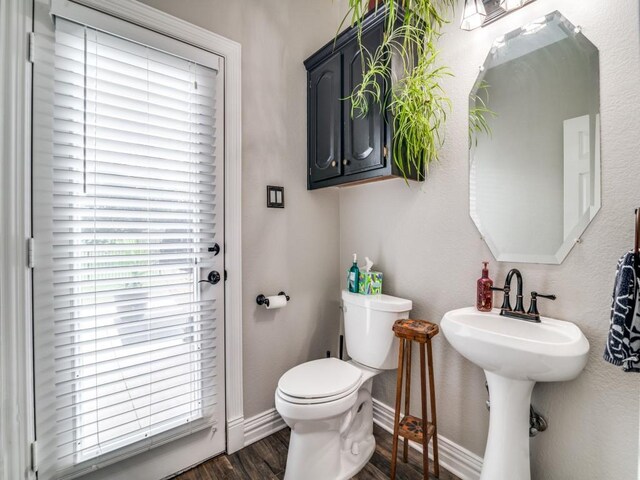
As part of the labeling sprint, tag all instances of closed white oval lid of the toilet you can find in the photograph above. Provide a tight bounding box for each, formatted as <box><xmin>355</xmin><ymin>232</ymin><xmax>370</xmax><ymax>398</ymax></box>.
<box><xmin>278</xmin><ymin>358</ymin><xmax>362</xmax><ymax>398</ymax></box>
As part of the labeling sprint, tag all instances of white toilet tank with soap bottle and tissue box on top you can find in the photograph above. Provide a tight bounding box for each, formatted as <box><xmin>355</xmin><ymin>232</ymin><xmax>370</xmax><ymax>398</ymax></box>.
<box><xmin>342</xmin><ymin>290</ymin><xmax>412</xmax><ymax>370</ymax></box>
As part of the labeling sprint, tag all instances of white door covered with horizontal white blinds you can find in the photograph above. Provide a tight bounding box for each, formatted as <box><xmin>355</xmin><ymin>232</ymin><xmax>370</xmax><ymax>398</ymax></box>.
<box><xmin>32</xmin><ymin>1</ymin><xmax>225</xmax><ymax>479</ymax></box>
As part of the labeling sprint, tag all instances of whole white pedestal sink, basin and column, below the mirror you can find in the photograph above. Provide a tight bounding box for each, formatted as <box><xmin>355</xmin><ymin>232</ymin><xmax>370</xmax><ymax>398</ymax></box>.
<box><xmin>440</xmin><ymin>308</ymin><xmax>589</xmax><ymax>480</ymax></box>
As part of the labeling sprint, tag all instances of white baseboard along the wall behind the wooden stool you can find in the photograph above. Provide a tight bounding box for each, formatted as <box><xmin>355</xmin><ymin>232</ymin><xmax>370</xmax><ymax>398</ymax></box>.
<box><xmin>373</xmin><ymin>398</ymin><xmax>482</xmax><ymax>480</ymax></box>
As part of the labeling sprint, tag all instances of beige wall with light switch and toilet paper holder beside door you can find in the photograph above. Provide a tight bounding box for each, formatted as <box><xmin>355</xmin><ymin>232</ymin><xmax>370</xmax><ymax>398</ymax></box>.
<box><xmin>138</xmin><ymin>0</ymin><xmax>345</xmax><ymax>418</ymax></box>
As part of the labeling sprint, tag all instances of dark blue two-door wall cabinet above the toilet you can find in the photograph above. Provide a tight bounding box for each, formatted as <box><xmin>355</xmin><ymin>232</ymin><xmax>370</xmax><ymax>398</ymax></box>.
<box><xmin>304</xmin><ymin>8</ymin><xmax>415</xmax><ymax>190</ymax></box>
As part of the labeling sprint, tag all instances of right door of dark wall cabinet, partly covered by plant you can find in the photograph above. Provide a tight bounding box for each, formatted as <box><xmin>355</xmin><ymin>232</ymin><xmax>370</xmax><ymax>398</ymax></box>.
<box><xmin>342</xmin><ymin>25</ymin><xmax>386</xmax><ymax>175</ymax></box>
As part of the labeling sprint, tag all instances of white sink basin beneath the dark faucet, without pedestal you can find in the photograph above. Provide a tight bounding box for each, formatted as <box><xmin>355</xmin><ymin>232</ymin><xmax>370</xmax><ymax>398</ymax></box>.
<box><xmin>440</xmin><ymin>307</ymin><xmax>589</xmax><ymax>382</ymax></box>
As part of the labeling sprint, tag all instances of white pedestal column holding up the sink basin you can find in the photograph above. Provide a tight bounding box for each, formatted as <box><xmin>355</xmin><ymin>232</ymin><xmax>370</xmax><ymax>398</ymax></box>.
<box><xmin>480</xmin><ymin>370</ymin><xmax>535</xmax><ymax>480</ymax></box>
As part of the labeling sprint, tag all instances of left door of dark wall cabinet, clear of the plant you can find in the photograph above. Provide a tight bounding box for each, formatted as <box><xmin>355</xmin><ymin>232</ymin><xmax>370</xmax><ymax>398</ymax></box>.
<box><xmin>308</xmin><ymin>53</ymin><xmax>342</xmax><ymax>183</ymax></box>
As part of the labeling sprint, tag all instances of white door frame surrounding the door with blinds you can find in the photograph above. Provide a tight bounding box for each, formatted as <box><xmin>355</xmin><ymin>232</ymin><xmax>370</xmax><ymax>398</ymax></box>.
<box><xmin>0</xmin><ymin>0</ymin><xmax>244</xmax><ymax>479</ymax></box>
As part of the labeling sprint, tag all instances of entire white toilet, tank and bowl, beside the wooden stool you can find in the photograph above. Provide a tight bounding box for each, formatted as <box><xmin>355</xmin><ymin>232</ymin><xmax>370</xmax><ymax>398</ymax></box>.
<box><xmin>275</xmin><ymin>291</ymin><xmax>412</xmax><ymax>480</ymax></box>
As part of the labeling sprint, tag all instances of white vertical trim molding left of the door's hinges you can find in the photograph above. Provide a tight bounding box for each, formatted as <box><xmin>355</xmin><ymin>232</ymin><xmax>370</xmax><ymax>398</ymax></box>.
<box><xmin>0</xmin><ymin>0</ymin><xmax>34</xmax><ymax>480</ymax></box>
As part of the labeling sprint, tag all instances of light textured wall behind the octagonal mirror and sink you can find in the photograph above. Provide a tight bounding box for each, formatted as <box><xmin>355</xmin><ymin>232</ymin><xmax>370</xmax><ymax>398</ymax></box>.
<box><xmin>340</xmin><ymin>0</ymin><xmax>640</xmax><ymax>480</ymax></box>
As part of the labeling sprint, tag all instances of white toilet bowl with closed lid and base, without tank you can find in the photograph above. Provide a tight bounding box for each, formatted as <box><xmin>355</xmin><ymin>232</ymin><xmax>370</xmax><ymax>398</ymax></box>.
<box><xmin>276</xmin><ymin>358</ymin><xmax>379</xmax><ymax>480</ymax></box>
